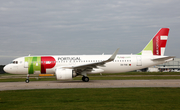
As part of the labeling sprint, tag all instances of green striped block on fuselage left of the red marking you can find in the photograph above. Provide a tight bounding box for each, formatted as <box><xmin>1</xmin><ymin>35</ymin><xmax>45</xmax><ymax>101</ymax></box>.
<box><xmin>25</xmin><ymin>57</ymin><xmax>41</xmax><ymax>74</ymax></box>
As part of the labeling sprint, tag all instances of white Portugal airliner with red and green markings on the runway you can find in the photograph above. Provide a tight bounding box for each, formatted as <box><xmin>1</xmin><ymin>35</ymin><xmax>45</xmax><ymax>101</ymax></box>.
<box><xmin>3</xmin><ymin>28</ymin><xmax>174</xmax><ymax>83</ymax></box>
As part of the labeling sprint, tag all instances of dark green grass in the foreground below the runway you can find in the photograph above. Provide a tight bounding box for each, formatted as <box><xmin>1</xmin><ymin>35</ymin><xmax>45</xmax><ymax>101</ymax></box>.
<box><xmin>0</xmin><ymin>88</ymin><xmax>180</xmax><ymax>110</ymax></box>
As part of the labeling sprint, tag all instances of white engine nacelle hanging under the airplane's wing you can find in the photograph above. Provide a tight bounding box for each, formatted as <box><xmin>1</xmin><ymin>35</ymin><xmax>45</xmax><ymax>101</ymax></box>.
<box><xmin>55</xmin><ymin>68</ymin><xmax>76</xmax><ymax>80</ymax></box>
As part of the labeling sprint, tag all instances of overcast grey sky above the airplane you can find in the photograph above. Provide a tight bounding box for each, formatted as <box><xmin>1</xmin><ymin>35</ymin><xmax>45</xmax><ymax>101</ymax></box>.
<box><xmin>0</xmin><ymin>0</ymin><xmax>180</xmax><ymax>65</ymax></box>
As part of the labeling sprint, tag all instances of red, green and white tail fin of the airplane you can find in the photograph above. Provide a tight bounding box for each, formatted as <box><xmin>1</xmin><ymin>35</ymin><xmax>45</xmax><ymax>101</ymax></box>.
<box><xmin>138</xmin><ymin>28</ymin><xmax>169</xmax><ymax>56</ymax></box>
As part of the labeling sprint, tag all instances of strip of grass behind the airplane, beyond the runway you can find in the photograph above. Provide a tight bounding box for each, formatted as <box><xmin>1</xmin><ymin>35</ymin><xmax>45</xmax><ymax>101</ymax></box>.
<box><xmin>0</xmin><ymin>72</ymin><xmax>180</xmax><ymax>82</ymax></box>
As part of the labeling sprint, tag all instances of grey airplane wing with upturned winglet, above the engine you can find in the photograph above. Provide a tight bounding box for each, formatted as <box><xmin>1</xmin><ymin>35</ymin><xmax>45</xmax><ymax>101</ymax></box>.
<box><xmin>61</xmin><ymin>48</ymin><xmax>119</xmax><ymax>69</ymax></box>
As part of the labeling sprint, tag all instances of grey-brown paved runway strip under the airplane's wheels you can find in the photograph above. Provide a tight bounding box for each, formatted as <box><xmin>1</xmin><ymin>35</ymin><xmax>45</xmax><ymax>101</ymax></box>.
<box><xmin>0</xmin><ymin>80</ymin><xmax>180</xmax><ymax>91</ymax></box>
